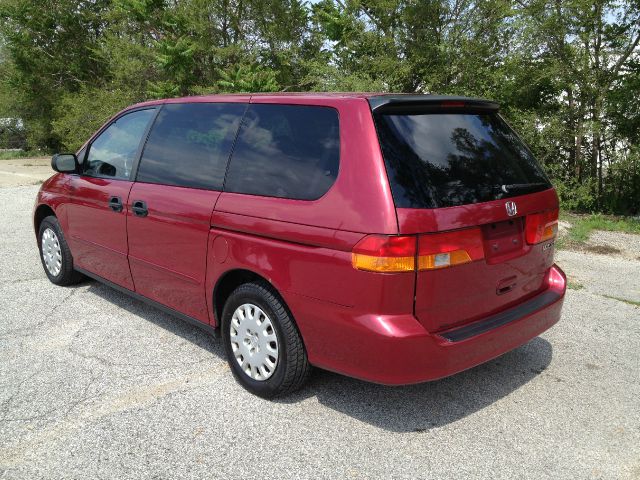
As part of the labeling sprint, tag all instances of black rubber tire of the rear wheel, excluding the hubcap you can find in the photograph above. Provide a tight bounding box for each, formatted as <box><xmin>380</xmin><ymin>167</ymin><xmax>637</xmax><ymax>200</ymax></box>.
<box><xmin>222</xmin><ymin>282</ymin><xmax>311</xmax><ymax>398</ymax></box>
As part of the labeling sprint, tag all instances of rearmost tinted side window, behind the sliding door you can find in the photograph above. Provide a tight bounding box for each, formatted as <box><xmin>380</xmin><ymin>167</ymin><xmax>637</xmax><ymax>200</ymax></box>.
<box><xmin>225</xmin><ymin>104</ymin><xmax>340</xmax><ymax>200</ymax></box>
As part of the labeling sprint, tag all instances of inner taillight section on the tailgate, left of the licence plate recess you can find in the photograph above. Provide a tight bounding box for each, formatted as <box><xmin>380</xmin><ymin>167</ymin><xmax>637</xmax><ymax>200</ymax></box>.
<box><xmin>418</xmin><ymin>228</ymin><xmax>484</xmax><ymax>270</ymax></box>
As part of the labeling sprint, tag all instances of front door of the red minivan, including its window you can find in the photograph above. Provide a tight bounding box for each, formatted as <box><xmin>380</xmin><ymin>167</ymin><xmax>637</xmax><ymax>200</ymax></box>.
<box><xmin>67</xmin><ymin>108</ymin><xmax>155</xmax><ymax>290</ymax></box>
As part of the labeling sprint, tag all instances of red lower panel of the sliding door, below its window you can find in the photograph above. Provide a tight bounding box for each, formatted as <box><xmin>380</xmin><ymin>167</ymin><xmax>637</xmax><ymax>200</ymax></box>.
<box><xmin>127</xmin><ymin>182</ymin><xmax>220</xmax><ymax>323</ymax></box>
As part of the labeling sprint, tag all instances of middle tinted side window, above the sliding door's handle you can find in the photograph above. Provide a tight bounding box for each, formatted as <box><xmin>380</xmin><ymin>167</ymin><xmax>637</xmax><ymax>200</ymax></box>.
<box><xmin>136</xmin><ymin>103</ymin><xmax>246</xmax><ymax>190</ymax></box>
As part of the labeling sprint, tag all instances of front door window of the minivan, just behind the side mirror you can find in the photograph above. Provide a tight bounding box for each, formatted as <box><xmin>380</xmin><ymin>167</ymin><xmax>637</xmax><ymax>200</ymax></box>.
<box><xmin>83</xmin><ymin>108</ymin><xmax>155</xmax><ymax>180</ymax></box>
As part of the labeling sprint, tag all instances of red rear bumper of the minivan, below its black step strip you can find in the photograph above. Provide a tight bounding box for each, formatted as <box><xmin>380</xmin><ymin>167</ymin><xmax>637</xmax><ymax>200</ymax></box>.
<box><xmin>287</xmin><ymin>266</ymin><xmax>565</xmax><ymax>385</ymax></box>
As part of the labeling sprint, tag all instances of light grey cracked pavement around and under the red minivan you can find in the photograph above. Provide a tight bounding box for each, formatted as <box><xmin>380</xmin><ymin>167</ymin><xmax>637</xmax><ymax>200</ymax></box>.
<box><xmin>0</xmin><ymin>179</ymin><xmax>640</xmax><ymax>479</ymax></box>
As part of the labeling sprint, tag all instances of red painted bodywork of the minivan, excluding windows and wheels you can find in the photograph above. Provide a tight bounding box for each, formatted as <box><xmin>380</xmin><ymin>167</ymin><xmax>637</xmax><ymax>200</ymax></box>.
<box><xmin>36</xmin><ymin>94</ymin><xmax>566</xmax><ymax>384</ymax></box>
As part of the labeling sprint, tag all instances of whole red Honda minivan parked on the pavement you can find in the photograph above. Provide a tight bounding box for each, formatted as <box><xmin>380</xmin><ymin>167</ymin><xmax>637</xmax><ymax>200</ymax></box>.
<box><xmin>34</xmin><ymin>93</ymin><xmax>566</xmax><ymax>397</ymax></box>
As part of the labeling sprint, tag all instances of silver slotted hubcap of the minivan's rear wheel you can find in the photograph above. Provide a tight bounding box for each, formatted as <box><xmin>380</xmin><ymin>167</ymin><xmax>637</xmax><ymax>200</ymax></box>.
<box><xmin>229</xmin><ymin>303</ymin><xmax>278</xmax><ymax>381</ymax></box>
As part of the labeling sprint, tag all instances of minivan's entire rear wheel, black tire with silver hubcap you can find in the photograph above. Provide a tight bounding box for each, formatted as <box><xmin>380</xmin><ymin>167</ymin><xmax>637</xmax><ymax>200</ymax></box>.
<box><xmin>222</xmin><ymin>283</ymin><xmax>311</xmax><ymax>398</ymax></box>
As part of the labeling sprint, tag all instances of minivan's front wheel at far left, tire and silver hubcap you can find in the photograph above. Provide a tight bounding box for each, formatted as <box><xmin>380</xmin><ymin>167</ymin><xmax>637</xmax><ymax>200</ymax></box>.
<box><xmin>38</xmin><ymin>216</ymin><xmax>84</xmax><ymax>285</ymax></box>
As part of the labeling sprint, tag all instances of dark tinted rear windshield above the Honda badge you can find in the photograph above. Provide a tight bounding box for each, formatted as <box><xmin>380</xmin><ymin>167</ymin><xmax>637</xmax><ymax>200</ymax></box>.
<box><xmin>374</xmin><ymin>113</ymin><xmax>551</xmax><ymax>208</ymax></box>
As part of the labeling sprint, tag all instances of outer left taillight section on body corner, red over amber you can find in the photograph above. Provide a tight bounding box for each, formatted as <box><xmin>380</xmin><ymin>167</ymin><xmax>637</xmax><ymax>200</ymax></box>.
<box><xmin>351</xmin><ymin>235</ymin><xmax>416</xmax><ymax>272</ymax></box>
